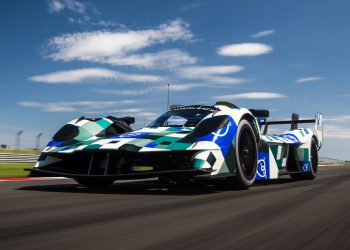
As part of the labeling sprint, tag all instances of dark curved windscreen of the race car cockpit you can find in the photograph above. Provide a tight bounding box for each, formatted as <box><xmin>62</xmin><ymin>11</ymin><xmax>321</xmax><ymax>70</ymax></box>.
<box><xmin>148</xmin><ymin>106</ymin><xmax>217</xmax><ymax>127</ymax></box>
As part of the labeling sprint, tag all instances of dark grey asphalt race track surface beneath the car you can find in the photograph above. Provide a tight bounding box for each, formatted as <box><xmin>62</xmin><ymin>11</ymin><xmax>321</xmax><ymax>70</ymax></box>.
<box><xmin>0</xmin><ymin>166</ymin><xmax>350</xmax><ymax>250</ymax></box>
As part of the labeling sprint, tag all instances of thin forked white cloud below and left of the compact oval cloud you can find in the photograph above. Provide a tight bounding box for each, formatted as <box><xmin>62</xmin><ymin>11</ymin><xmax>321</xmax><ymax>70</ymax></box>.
<box><xmin>178</xmin><ymin>65</ymin><xmax>245</xmax><ymax>84</ymax></box>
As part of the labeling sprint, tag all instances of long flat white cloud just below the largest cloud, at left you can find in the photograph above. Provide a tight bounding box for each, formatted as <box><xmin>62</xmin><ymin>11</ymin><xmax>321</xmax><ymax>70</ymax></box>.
<box><xmin>28</xmin><ymin>68</ymin><xmax>164</xmax><ymax>84</ymax></box>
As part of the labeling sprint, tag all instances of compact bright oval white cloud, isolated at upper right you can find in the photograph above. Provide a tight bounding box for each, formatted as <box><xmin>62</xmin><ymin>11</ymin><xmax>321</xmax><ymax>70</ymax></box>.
<box><xmin>217</xmin><ymin>43</ymin><xmax>273</xmax><ymax>56</ymax></box>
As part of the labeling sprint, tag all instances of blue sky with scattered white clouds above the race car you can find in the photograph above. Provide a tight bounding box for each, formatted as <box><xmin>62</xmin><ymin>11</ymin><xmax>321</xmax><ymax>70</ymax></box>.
<box><xmin>0</xmin><ymin>0</ymin><xmax>350</xmax><ymax>159</ymax></box>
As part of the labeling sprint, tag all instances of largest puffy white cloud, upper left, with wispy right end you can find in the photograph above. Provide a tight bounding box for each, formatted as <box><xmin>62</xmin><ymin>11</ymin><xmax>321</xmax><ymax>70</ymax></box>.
<box><xmin>48</xmin><ymin>19</ymin><xmax>197</xmax><ymax>67</ymax></box>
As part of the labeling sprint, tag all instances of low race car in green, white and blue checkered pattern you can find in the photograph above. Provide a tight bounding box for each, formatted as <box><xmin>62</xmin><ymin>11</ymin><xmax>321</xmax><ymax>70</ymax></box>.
<box><xmin>29</xmin><ymin>101</ymin><xmax>323</xmax><ymax>189</ymax></box>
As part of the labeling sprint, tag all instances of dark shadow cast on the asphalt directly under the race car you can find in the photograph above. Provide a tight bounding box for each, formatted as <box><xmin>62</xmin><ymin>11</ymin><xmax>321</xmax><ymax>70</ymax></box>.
<box><xmin>16</xmin><ymin>179</ymin><xmax>294</xmax><ymax>195</ymax></box>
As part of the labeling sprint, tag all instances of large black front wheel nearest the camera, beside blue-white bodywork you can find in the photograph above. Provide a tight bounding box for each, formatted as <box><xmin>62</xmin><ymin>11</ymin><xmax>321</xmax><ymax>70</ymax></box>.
<box><xmin>235</xmin><ymin>120</ymin><xmax>258</xmax><ymax>189</ymax></box>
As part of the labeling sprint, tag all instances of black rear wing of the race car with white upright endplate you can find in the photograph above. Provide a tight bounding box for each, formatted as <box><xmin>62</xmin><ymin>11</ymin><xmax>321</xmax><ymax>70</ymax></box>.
<box><xmin>258</xmin><ymin>113</ymin><xmax>323</xmax><ymax>149</ymax></box>
